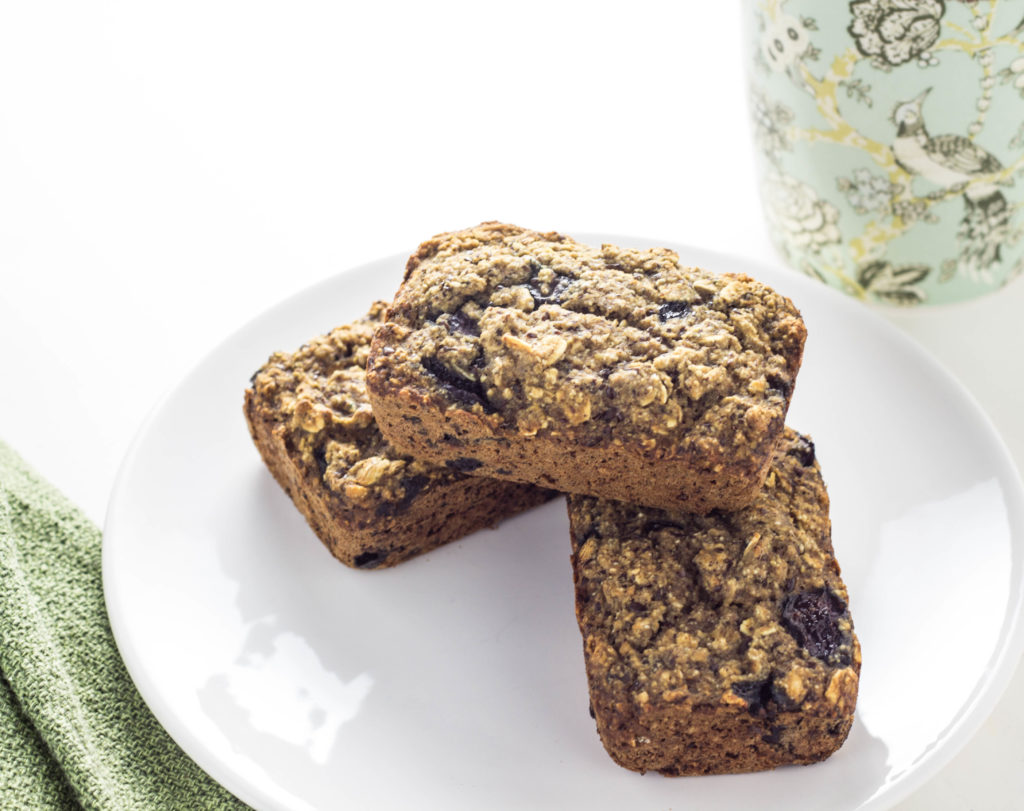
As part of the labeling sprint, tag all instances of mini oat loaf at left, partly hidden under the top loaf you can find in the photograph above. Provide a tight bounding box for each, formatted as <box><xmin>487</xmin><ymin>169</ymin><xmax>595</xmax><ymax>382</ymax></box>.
<box><xmin>245</xmin><ymin>302</ymin><xmax>554</xmax><ymax>568</ymax></box>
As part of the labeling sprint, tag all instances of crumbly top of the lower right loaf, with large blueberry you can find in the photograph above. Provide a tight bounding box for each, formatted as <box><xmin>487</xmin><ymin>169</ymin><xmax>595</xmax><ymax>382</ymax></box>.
<box><xmin>569</xmin><ymin>428</ymin><xmax>860</xmax><ymax>715</ymax></box>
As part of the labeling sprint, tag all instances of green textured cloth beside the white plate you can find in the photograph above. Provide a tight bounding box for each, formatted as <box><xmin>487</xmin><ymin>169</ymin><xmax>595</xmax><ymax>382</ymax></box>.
<box><xmin>0</xmin><ymin>442</ymin><xmax>246</xmax><ymax>811</ymax></box>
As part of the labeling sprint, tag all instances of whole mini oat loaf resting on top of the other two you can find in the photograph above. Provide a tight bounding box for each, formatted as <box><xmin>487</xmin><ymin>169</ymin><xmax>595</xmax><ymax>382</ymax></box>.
<box><xmin>367</xmin><ymin>223</ymin><xmax>806</xmax><ymax>513</ymax></box>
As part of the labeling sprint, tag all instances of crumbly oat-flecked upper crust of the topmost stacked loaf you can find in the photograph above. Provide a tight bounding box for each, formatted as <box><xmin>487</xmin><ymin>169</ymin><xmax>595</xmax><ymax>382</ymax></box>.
<box><xmin>375</xmin><ymin>223</ymin><xmax>805</xmax><ymax>455</ymax></box>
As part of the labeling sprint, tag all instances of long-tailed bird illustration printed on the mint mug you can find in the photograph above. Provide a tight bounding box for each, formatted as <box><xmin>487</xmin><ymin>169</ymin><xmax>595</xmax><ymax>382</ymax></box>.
<box><xmin>892</xmin><ymin>88</ymin><xmax>1013</xmax><ymax>278</ymax></box>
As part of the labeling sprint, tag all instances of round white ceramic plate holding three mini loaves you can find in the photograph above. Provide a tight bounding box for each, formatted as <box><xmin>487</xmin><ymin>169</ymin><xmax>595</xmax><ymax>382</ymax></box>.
<box><xmin>103</xmin><ymin>236</ymin><xmax>1024</xmax><ymax>811</ymax></box>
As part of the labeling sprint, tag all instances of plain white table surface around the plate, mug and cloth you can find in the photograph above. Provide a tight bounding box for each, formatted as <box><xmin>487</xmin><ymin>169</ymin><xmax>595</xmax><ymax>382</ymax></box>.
<box><xmin>0</xmin><ymin>0</ymin><xmax>1024</xmax><ymax>811</ymax></box>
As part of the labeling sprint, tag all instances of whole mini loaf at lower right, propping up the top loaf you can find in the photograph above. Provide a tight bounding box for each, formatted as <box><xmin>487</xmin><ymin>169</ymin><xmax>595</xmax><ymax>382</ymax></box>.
<box><xmin>568</xmin><ymin>430</ymin><xmax>860</xmax><ymax>775</ymax></box>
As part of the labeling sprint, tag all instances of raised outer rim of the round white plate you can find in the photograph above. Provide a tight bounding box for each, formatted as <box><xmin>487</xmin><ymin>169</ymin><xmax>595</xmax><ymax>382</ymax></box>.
<box><xmin>101</xmin><ymin>231</ymin><xmax>1024</xmax><ymax>811</ymax></box>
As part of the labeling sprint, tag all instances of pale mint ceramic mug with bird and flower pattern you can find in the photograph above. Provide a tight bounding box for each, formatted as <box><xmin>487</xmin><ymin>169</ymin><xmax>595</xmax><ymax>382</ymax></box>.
<box><xmin>743</xmin><ymin>0</ymin><xmax>1024</xmax><ymax>305</ymax></box>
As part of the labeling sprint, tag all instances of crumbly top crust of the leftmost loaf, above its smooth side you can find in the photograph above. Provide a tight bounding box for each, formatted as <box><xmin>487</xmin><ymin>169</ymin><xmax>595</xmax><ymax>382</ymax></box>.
<box><xmin>245</xmin><ymin>301</ymin><xmax>460</xmax><ymax>515</ymax></box>
